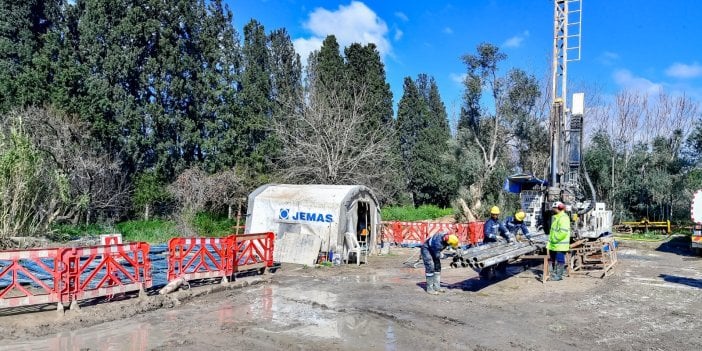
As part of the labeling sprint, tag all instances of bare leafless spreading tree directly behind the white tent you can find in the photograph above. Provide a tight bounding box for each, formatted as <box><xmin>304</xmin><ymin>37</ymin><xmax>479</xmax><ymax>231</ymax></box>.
<box><xmin>276</xmin><ymin>81</ymin><xmax>395</xmax><ymax>198</ymax></box>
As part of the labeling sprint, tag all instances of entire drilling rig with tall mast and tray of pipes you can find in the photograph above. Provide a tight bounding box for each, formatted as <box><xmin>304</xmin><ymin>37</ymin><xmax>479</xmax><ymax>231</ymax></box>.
<box><xmin>452</xmin><ymin>0</ymin><xmax>617</xmax><ymax>277</ymax></box>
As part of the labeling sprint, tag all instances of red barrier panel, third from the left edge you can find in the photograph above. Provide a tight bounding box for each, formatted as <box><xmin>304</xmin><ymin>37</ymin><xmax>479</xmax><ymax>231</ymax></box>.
<box><xmin>167</xmin><ymin>237</ymin><xmax>234</xmax><ymax>282</ymax></box>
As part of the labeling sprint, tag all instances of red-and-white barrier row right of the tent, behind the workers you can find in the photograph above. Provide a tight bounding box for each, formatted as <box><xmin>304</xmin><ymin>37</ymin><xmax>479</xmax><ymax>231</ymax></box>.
<box><xmin>381</xmin><ymin>221</ymin><xmax>484</xmax><ymax>245</ymax></box>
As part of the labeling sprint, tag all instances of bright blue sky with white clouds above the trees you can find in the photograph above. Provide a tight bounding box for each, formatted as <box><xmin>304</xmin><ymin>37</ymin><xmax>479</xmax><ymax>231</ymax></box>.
<box><xmin>225</xmin><ymin>0</ymin><xmax>702</xmax><ymax>120</ymax></box>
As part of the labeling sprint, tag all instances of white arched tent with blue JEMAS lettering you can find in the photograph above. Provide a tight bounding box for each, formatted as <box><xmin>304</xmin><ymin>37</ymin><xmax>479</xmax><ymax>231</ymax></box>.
<box><xmin>246</xmin><ymin>184</ymin><xmax>380</xmax><ymax>264</ymax></box>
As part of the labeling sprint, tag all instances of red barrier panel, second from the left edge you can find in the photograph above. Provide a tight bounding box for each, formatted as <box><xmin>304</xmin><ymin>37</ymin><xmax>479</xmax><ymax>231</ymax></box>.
<box><xmin>60</xmin><ymin>242</ymin><xmax>152</xmax><ymax>300</ymax></box>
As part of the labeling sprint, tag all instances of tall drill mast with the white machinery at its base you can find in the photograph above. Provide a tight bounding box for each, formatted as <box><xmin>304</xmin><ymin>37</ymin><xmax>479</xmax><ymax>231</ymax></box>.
<box><xmin>541</xmin><ymin>0</ymin><xmax>612</xmax><ymax>238</ymax></box>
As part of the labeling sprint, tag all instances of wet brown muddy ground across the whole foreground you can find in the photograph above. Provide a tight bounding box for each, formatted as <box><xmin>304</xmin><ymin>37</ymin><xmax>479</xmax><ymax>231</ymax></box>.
<box><xmin>0</xmin><ymin>241</ymin><xmax>702</xmax><ymax>351</ymax></box>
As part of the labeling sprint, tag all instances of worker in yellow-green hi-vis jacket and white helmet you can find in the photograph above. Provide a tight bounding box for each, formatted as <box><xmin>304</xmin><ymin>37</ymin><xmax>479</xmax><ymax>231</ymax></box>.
<box><xmin>547</xmin><ymin>201</ymin><xmax>570</xmax><ymax>281</ymax></box>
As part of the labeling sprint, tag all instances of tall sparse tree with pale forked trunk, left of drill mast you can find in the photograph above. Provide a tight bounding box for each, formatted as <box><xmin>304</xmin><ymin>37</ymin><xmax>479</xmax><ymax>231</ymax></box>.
<box><xmin>454</xmin><ymin>43</ymin><xmax>538</xmax><ymax>216</ymax></box>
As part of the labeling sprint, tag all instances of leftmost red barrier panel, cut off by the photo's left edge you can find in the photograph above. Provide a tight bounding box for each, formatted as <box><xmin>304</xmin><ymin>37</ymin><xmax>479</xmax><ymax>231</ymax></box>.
<box><xmin>0</xmin><ymin>248</ymin><xmax>67</xmax><ymax>308</ymax></box>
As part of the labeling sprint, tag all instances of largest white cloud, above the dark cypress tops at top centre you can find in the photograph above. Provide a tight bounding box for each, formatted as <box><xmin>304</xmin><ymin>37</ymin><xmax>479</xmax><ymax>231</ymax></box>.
<box><xmin>293</xmin><ymin>1</ymin><xmax>390</xmax><ymax>62</ymax></box>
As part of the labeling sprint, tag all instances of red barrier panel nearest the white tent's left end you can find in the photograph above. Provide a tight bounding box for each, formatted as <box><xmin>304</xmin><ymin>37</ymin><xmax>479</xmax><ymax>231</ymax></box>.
<box><xmin>230</xmin><ymin>232</ymin><xmax>275</xmax><ymax>272</ymax></box>
